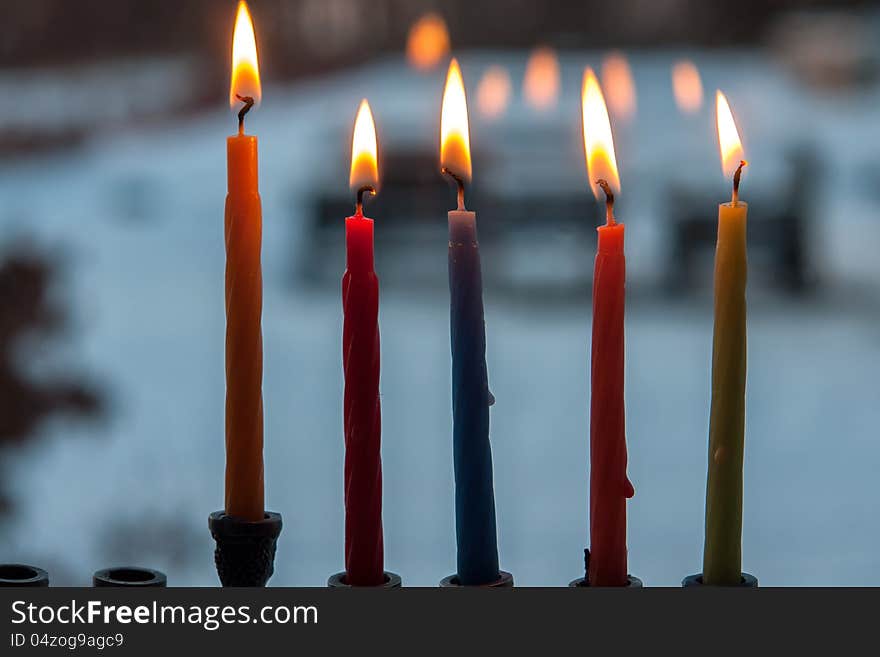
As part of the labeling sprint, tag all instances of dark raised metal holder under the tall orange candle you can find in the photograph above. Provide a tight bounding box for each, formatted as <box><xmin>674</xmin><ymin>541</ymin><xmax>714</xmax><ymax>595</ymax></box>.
<box><xmin>208</xmin><ymin>511</ymin><xmax>282</xmax><ymax>587</ymax></box>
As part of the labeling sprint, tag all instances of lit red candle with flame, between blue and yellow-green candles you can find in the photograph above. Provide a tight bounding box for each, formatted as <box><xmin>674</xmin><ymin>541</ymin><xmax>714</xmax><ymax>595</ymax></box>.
<box><xmin>582</xmin><ymin>68</ymin><xmax>633</xmax><ymax>586</ymax></box>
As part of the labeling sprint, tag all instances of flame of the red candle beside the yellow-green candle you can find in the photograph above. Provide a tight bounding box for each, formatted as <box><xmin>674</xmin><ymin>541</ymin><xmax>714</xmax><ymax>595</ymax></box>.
<box><xmin>582</xmin><ymin>67</ymin><xmax>620</xmax><ymax>199</ymax></box>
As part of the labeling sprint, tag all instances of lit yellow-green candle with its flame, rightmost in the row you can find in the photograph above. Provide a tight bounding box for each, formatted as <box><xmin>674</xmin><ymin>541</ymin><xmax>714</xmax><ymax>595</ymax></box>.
<box><xmin>703</xmin><ymin>91</ymin><xmax>748</xmax><ymax>586</ymax></box>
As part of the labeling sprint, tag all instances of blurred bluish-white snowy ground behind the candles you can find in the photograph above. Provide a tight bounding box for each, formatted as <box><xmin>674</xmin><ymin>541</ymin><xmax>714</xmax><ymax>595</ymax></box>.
<box><xmin>0</xmin><ymin>54</ymin><xmax>880</xmax><ymax>586</ymax></box>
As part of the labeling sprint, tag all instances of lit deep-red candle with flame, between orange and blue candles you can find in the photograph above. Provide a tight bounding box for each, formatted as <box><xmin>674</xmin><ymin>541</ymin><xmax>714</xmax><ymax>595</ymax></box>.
<box><xmin>342</xmin><ymin>100</ymin><xmax>385</xmax><ymax>586</ymax></box>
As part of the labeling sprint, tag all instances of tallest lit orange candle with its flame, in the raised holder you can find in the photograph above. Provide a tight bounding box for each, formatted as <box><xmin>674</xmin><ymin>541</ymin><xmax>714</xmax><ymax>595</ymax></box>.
<box><xmin>224</xmin><ymin>2</ymin><xmax>264</xmax><ymax>521</ymax></box>
